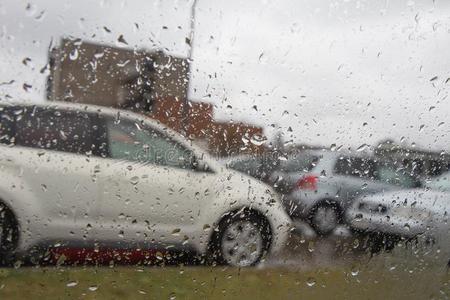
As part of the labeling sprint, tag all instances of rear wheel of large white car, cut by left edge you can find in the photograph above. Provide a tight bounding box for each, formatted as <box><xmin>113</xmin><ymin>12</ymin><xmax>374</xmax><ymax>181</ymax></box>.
<box><xmin>0</xmin><ymin>203</ymin><xmax>19</xmax><ymax>266</ymax></box>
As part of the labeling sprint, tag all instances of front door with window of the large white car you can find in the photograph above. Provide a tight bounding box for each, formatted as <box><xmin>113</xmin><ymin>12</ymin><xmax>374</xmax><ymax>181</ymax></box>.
<box><xmin>97</xmin><ymin>115</ymin><xmax>215</xmax><ymax>247</ymax></box>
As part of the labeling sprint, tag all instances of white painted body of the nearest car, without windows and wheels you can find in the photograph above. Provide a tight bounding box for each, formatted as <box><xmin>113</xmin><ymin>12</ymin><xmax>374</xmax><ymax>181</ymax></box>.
<box><xmin>0</xmin><ymin>103</ymin><xmax>291</xmax><ymax>264</ymax></box>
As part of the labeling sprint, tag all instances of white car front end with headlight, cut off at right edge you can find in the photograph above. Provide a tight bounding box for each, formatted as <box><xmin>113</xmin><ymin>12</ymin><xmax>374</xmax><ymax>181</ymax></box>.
<box><xmin>346</xmin><ymin>173</ymin><xmax>450</xmax><ymax>261</ymax></box>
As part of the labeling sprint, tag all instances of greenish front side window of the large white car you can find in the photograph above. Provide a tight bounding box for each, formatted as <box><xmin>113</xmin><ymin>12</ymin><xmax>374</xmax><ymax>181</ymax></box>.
<box><xmin>107</xmin><ymin>120</ymin><xmax>195</xmax><ymax>169</ymax></box>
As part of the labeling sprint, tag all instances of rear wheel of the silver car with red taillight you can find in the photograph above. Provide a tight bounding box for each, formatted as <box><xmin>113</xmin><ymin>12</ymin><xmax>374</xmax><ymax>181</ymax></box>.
<box><xmin>308</xmin><ymin>202</ymin><xmax>342</xmax><ymax>237</ymax></box>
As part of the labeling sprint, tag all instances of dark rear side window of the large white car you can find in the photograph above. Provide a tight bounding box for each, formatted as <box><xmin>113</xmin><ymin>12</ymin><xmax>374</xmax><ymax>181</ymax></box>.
<box><xmin>15</xmin><ymin>107</ymin><xmax>95</xmax><ymax>155</ymax></box>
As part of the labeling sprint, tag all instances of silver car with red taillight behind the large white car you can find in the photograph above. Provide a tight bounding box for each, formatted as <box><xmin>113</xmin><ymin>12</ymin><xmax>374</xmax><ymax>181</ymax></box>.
<box><xmin>279</xmin><ymin>150</ymin><xmax>421</xmax><ymax>235</ymax></box>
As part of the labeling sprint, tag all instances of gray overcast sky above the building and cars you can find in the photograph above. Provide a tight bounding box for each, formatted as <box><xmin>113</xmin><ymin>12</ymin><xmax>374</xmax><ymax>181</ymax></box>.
<box><xmin>0</xmin><ymin>0</ymin><xmax>450</xmax><ymax>151</ymax></box>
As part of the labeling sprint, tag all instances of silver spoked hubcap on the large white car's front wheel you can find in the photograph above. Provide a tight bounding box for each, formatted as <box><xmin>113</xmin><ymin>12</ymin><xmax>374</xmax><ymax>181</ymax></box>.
<box><xmin>221</xmin><ymin>221</ymin><xmax>263</xmax><ymax>267</ymax></box>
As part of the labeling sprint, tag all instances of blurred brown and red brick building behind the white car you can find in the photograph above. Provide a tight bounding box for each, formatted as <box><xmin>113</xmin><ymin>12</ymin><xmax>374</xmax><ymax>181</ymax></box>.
<box><xmin>47</xmin><ymin>39</ymin><xmax>265</xmax><ymax>156</ymax></box>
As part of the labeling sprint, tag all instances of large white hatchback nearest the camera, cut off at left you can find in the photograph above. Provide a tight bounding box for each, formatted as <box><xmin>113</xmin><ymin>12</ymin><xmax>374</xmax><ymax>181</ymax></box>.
<box><xmin>0</xmin><ymin>103</ymin><xmax>291</xmax><ymax>266</ymax></box>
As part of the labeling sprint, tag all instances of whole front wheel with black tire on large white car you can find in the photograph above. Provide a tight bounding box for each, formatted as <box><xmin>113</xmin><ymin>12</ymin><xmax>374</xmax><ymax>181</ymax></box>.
<box><xmin>208</xmin><ymin>211</ymin><xmax>272</xmax><ymax>267</ymax></box>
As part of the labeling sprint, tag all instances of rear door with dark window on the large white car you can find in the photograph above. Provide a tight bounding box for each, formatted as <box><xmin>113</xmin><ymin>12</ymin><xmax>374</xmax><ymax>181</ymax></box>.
<box><xmin>9</xmin><ymin>107</ymin><xmax>104</xmax><ymax>247</ymax></box>
